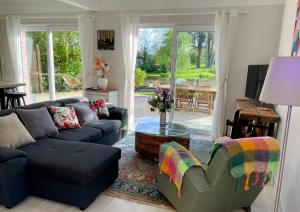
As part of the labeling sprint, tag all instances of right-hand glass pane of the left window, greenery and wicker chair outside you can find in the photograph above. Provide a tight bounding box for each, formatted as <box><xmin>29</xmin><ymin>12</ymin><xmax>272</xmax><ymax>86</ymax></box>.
<box><xmin>52</xmin><ymin>31</ymin><xmax>82</xmax><ymax>99</ymax></box>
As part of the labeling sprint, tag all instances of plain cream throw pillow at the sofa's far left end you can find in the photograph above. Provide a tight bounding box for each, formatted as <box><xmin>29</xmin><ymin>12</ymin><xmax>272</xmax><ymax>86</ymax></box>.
<box><xmin>0</xmin><ymin>113</ymin><xmax>35</xmax><ymax>148</ymax></box>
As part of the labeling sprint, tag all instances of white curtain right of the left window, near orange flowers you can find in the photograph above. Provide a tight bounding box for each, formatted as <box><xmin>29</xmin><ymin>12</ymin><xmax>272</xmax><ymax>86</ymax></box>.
<box><xmin>78</xmin><ymin>15</ymin><xmax>95</xmax><ymax>88</ymax></box>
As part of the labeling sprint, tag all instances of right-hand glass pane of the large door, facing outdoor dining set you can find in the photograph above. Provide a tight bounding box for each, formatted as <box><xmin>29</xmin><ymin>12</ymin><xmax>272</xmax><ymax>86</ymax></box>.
<box><xmin>173</xmin><ymin>31</ymin><xmax>216</xmax><ymax>133</ymax></box>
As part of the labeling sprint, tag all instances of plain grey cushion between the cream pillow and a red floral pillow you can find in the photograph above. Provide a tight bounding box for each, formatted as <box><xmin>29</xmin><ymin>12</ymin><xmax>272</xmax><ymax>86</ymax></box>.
<box><xmin>17</xmin><ymin>107</ymin><xmax>58</xmax><ymax>139</ymax></box>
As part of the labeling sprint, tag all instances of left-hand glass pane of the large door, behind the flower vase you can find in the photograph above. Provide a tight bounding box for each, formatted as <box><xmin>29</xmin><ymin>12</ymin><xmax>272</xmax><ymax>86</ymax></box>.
<box><xmin>134</xmin><ymin>28</ymin><xmax>173</xmax><ymax>126</ymax></box>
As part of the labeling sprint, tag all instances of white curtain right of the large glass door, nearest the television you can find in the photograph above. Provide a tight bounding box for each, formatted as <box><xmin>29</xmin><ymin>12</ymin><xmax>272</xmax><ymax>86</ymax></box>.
<box><xmin>212</xmin><ymin>10</ymin><xmax>239</xmax><ymax>139</ymax></box>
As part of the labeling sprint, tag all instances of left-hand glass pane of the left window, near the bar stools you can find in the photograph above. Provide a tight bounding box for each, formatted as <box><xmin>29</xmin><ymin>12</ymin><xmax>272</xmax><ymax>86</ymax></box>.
<box><xmin>21</xmin><ymin>31</ymin><xmax>50</xmax><ymax>104</ymax></box>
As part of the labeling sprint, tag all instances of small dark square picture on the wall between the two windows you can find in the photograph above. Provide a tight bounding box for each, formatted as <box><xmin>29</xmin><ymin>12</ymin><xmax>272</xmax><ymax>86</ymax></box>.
<box><xmin>97</xmin><ymin>30</ymin><xmax>115</xmax><ymax>50</ymax></box>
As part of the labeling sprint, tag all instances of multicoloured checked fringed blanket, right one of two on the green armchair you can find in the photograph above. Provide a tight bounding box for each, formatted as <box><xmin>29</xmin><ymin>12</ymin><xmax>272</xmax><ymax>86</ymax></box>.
<box><xmin>212</xmin><ymin>137</ymin><xmax>280</xmax><ymax>190</ymax></box>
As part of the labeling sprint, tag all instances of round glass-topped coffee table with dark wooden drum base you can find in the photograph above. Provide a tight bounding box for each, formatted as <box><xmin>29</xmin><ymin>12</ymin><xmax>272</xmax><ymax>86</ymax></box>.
<box><xmin>130</xmin><ymin>121</ymin><xmax>190</xmax><ymax>158</ymax></box>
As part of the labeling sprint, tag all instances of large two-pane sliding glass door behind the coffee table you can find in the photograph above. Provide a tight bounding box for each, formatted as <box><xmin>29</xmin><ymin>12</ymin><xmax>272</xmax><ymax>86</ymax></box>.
<box><xmin>135</xmin><ymin>26</ymin><xmax>216</xmax><ymax>135</ymax></box>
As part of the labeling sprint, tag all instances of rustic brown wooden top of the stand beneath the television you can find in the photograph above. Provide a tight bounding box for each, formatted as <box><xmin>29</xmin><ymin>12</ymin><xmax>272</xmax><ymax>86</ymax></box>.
<box><xmin>236</xmin><ymin>99</ymin><xmax>280</xmax><ymax>123</ymax></box>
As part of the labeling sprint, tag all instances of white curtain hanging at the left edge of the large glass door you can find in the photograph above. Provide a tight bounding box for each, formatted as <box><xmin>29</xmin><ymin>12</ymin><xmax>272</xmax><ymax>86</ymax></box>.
<box><xmin>121</xmin><ymin>13</ymin><xmax>139</xmax><ymax>129</ymax></box>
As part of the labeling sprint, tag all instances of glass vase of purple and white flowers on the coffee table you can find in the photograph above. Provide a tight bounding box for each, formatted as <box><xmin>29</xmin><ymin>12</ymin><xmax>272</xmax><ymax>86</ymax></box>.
<box><xmin>148</xmin><ymin>88</ymin><xmax>174</xmax><ymax>131</ymax></box>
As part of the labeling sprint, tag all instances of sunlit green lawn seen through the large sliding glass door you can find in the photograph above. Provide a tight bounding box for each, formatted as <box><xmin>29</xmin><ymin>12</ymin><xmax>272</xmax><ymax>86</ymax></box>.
<box><xmin>146</xmin><ymin>66</ymin><xmax>215</xmax><ymax>80</ymax></box>
